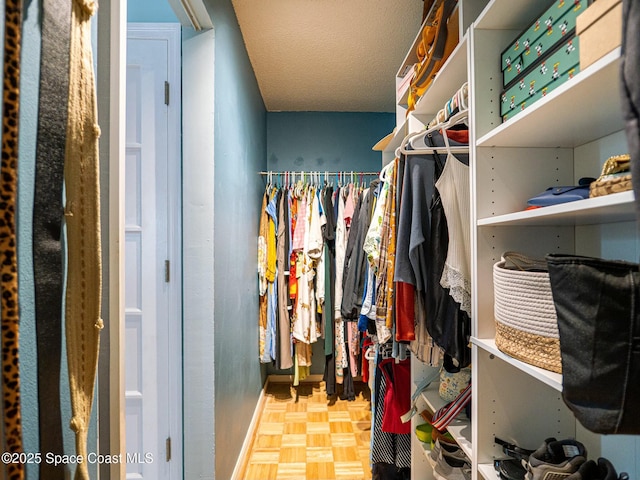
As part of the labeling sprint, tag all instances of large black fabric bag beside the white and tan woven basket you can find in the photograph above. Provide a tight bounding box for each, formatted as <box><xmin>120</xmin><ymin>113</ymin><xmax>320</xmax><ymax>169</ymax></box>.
<box><xmin>546</xmin><ymin>254</ymin><xmax>640</xmax><ymax>435</ymax></box>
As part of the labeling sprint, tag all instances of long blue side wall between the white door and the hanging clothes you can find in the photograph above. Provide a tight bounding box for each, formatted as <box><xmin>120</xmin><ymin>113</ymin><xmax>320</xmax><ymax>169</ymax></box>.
<box><xmin>204</xmin><ymin>0</ymin><xmax>267</xmax><ymax>478</ymax></box>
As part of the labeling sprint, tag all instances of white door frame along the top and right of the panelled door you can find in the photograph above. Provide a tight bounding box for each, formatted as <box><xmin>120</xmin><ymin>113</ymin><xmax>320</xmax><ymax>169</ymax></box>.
<box><xmin>121</xmin><ymin>22</ymin><xmax>183</xmax><ymax>479</ymax></box>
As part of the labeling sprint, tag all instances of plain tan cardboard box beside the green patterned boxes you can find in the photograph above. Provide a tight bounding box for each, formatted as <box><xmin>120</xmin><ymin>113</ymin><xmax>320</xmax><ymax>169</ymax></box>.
<box><xmin>576</xmin><ymin>0</ymin><xmax>622</xmax><ymax>70</ymax></box>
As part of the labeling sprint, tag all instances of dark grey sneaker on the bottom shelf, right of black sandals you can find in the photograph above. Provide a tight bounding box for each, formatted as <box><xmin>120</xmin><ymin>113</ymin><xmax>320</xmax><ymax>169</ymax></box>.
<box><xmin>525</xmin><ymin>438</ymin><xmax>587</xmax><ymax>480</ymax></box>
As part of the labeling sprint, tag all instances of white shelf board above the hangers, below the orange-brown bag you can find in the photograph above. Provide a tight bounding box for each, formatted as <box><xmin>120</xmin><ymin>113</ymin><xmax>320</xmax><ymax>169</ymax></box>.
<box><xmin>412</xmin><ymin>33</ymin><xmax>469</xmax><ymax>123</ymax></box>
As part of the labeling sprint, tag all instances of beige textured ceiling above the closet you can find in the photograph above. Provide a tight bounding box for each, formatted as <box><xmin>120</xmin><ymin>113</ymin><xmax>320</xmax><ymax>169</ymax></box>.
<box><xmin>232</xmin><ymin>0</ymin><xmax>423</xmax><ymax>112</ymax></box>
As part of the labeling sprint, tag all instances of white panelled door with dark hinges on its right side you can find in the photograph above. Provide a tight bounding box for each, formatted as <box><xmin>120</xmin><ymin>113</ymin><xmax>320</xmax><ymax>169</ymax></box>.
<box><xmin>125</xmin><ymin>24</ymin><xmax>182</xmax><ymax>480</ymax></box>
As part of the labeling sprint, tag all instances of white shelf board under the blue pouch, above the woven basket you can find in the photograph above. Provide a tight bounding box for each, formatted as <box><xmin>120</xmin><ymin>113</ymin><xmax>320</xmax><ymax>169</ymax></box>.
<box><xmin>478</xmin><ymin>190</ymin><xmax>636</xmax><ymax>227</ymax></box>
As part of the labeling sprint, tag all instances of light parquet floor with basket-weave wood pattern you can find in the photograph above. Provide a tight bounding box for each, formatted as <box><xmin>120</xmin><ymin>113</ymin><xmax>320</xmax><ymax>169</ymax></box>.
<box><xmin>242</xmin><ymin>382</ymin><xmax>371</xmax><ymax>480</ymax></box>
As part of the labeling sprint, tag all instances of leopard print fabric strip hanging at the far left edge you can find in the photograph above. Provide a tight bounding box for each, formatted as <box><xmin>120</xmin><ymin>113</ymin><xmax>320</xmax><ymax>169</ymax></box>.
<box><xmin>0</xmin><ymin>0</ymin><xmax>24</xmax><ymax>480</ymax></box>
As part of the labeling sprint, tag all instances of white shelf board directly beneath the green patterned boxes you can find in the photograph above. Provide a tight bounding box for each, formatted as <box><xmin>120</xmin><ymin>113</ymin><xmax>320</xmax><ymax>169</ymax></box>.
<box><xmin>476</xmin><ymin>48</ymin><xmax>624</xmax><ymax>148</ymax></box>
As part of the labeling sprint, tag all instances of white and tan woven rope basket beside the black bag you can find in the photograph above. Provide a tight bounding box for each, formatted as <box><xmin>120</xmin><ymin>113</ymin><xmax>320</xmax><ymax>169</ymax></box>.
<box><xmin>493</xmin><ymin>252</ymin><xmax>562</xmax><ymax>373</ymax></box>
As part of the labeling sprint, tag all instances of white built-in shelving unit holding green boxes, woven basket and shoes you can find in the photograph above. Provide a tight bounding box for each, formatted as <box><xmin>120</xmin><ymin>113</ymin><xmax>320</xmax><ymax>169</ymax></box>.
<box><xmin>383</xmin><ymin>0</ymin><xmax>640</xmax><ymax>480</ymax></box>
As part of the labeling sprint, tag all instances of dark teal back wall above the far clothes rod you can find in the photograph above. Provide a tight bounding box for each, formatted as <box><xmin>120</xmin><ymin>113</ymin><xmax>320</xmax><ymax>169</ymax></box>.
<box><xmin>267</xmin><ymin>112</ymin><xmax>395</xmax><ymax>172</ymax></box>
